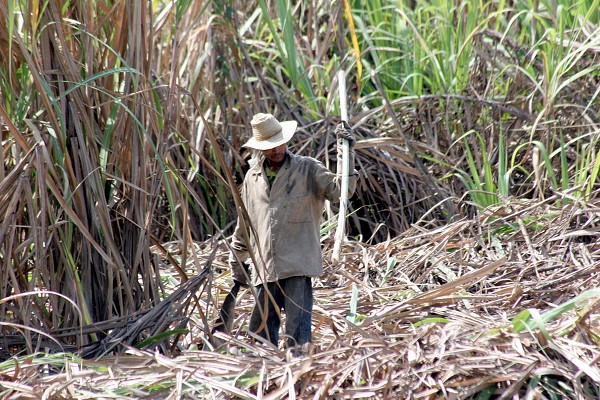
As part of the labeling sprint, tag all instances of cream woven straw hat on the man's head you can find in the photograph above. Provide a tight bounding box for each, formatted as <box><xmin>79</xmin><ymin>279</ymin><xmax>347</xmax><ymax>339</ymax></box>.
<box><xmin>244</xmin><ymin>113</ymin><xmax>298</xmax><ymax>150</ymax></box>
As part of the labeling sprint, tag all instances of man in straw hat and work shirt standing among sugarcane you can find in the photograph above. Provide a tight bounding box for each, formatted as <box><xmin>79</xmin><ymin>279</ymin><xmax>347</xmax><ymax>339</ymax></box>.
<box><xmin>229</xmin><ymin>113</ymin><xmax>358</xmax><ymax>349</ymax></box>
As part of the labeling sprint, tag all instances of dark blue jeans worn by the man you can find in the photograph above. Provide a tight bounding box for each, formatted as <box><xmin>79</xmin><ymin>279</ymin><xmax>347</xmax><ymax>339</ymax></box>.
<box><xmin>248</xmin><ymin>276</ymin><xmax>313</xmax><ymax>347</ymax></box>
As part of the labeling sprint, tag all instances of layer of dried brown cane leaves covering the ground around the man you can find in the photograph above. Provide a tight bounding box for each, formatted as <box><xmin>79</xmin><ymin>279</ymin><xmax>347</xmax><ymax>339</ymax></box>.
<box><xmin>2</xmin><ymin>199</ymin><xmax>600</xmax><ymax>399</ymax></box>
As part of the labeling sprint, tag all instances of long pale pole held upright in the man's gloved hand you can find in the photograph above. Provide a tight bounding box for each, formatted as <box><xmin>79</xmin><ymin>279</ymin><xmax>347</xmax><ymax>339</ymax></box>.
<box><xmin>331</xmin><ymin>69</ymin><xmax>350</xmax><ymax>265</ymax></box>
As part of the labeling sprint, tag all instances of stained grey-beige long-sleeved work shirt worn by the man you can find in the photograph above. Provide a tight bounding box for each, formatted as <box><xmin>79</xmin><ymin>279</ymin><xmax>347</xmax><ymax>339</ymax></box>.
<box><xmin>230</xmin><ymin>151</ymin><xmax>358</xmax><ymax>286</ymax></box>
